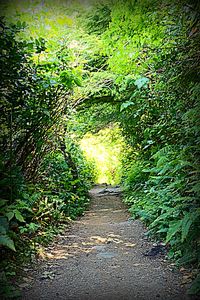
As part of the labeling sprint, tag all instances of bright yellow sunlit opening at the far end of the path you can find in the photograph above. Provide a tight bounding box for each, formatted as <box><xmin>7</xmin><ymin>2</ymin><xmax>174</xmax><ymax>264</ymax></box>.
<box><xmin>80</xmin><ymin>126</ymin><xmax>124</xmax><ymax>184</ymax></box>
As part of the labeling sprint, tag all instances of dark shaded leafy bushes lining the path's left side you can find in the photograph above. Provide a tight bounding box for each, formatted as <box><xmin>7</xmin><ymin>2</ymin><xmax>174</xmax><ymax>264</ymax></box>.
<box><xmin>0</xmin><ymin>15</ymin><xmax>93</xmax><ymax>298</ymax></box>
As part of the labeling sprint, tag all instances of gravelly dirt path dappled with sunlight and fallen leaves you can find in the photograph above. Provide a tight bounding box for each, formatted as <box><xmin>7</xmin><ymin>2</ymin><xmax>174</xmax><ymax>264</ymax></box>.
<box><xmin>22</xmin><ymin>187</ymin><xmax>190</xmax><ymax>300</ymax></box>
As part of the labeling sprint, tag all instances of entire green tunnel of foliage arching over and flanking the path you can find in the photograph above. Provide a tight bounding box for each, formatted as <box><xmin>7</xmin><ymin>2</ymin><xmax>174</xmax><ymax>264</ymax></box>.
<box><xmin>0</xmin><ymin>0</ymin><xmax>200</xmax><ymax>294</ymax></box>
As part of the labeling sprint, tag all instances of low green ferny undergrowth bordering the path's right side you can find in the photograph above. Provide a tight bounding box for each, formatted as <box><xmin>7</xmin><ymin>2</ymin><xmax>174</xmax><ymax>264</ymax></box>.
<box><xmin>123</xmin><ymin>146</ymin><xmax>200</xmax><ymax>294</ymax></box>
